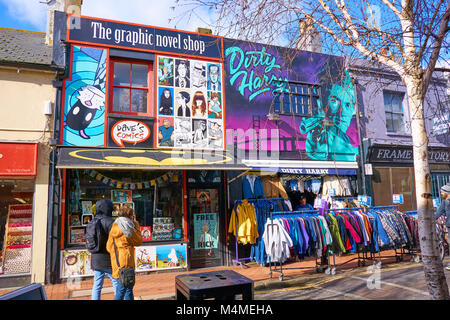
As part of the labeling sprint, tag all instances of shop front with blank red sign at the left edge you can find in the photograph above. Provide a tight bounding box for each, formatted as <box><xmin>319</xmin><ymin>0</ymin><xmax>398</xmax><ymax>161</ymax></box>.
<box><xmin>0</xmin><ymin>142</ymin><xmax>38</xmax><ymax>287</ymax></box>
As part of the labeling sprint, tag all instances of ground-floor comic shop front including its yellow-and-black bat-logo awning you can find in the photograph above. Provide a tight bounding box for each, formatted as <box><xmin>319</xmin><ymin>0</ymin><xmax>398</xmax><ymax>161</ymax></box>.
<box><xmin>57</xmin><ymin>147</ymin><xmax>250</xmax><ymax>278</ymax></box>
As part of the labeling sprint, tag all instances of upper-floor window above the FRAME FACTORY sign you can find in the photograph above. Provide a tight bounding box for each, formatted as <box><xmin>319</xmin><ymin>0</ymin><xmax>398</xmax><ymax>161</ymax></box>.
<box><xmin>383</xmin><ymin>91</ymin><xmax>405</xmax><ymax>132</ymax></box>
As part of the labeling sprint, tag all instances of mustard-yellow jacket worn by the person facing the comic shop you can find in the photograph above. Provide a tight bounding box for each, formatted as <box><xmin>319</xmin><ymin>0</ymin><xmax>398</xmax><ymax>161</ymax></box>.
<box><xmin>106</xmin><ymin>221</ymin><xmax>142</xmax><ymax>279</ymax></box>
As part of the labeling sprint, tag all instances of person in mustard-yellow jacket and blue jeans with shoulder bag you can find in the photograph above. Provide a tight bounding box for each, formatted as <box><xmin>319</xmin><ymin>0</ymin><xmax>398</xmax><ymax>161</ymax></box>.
<box><xmin>106</xmin><ymin>207</ymin><xmax>142</xmax><ymax>300</ymax></box>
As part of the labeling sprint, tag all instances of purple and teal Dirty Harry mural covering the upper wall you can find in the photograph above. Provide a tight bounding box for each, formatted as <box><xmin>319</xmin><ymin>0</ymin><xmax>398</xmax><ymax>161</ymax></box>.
<box><xmin>224</xmin><ymin>39</ymin><xmax>359</xmax><ymax>161</ymax></box>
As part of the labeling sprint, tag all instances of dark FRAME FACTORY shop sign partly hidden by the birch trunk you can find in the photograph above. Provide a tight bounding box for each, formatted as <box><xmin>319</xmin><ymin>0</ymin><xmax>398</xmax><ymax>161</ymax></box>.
<box><xmin>369</xmin><ymin>146</ymin><xmax>450</xmax><ymax>164</ymax></box>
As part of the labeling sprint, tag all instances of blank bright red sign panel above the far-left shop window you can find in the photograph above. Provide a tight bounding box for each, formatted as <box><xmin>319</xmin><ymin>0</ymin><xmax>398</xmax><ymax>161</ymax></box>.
<box><xmin>0</xmin><ymin>142</ymin><xmax>37</xmax><ymax>177</ymax></box>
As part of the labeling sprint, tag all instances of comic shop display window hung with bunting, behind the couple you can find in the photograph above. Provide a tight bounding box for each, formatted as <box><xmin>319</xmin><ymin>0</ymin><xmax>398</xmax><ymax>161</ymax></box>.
<box><xmin>66</xmin><ymin>170</ymin><xmax>185</xmax><ymax>246</ymax></box>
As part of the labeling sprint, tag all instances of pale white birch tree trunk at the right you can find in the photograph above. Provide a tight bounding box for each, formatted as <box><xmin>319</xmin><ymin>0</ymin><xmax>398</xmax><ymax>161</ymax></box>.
<box><xmin>404</xmin><ymin>78</ymin><xmax>449</xmax><ymax>300</ymax></box>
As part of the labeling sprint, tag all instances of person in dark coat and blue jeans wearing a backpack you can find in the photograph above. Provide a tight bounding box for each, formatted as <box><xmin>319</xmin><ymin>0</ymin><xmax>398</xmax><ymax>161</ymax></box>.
<box><xmin>85</xmin><ymin>199</ymin><xmax>119</xmax><ymax>300</ymax></box>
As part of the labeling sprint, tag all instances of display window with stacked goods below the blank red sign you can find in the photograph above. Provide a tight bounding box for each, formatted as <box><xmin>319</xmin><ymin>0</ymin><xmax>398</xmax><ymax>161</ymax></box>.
<box><xmin>0</xmin><ymin>179</ymin><xmax>34</xmax><ymax>275</ymax></box>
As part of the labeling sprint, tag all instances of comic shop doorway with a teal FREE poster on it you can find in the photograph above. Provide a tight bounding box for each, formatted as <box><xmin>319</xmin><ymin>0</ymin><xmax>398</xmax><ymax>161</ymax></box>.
<box><xmin>187</xmin><ymin>173</ymin><xmax>224</xmax><ymax>269</ymax></box>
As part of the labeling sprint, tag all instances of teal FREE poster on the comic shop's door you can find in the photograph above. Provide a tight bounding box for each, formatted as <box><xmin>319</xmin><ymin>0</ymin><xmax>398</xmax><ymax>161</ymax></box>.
<box><xmin>194</xmin><ymin>213</ymin><xmax>218</xmax><ymax>250</ymax></box>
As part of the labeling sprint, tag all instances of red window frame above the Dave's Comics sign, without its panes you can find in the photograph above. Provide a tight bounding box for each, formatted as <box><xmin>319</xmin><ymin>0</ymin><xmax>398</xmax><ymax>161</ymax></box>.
<box><xmin>108</xmin><ymin>59</ymin><xmax>154</xmax><ymax>117</ymax></box>
